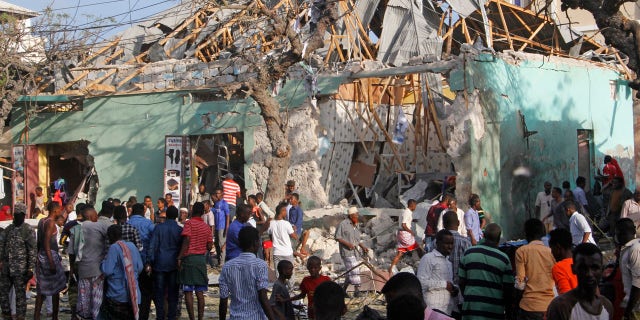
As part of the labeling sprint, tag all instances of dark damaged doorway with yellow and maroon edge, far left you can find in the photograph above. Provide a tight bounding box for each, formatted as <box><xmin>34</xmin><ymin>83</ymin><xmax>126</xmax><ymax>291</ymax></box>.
<box><xmin>38</xmin><ymin>140</ymin><xmax>98</xmax><ymax>210</ymax></box>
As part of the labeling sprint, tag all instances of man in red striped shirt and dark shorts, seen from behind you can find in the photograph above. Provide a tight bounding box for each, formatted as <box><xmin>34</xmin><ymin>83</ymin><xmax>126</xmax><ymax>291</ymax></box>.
<box><xmin>178</xmin><ymin>202</ymin><xmax>213</xmax><ymax>320</ymax></box>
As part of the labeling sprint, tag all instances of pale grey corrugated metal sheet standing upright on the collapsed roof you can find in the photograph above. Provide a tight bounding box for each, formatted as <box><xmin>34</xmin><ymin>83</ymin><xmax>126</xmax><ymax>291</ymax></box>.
<box><xmin>377</xmin><ymin>0</ymin><xmax>442</xmax><ymax>66</ymax></box>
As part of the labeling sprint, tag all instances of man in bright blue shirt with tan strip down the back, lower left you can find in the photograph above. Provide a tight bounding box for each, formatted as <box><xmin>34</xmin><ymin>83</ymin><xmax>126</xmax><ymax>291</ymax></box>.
<box><xmin>100</xmin><ymin>225</ymin><xmax>143</xmax><ymax>319</ymax></box>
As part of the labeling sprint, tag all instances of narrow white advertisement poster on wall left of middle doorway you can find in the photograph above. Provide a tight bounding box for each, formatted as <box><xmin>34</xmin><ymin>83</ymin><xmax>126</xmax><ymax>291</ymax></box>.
<box><xmin>164</xmin><ymin>136</ymin><xmax>185</xmax><ymax>206</ymax></box>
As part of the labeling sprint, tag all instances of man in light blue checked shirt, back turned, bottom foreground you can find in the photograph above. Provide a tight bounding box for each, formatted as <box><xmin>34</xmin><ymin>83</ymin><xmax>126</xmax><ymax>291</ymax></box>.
<box><xmin>218</xmin><ymin>226</ymin><xmax>276</xmax><ymax>320</ymax></box>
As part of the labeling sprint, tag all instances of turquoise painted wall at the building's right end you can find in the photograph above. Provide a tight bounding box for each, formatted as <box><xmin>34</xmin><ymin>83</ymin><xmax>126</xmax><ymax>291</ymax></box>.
<box><xmin>460</xmin><ymin>55</ymin><xmax>635</xmax><ymax>238</ymax></box>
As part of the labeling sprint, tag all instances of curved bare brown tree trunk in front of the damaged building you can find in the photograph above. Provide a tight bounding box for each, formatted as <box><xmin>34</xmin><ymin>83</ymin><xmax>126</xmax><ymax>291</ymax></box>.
<box><xmin>251</xmin><ymin>85</ymin><xmax>291</xmax><ymax>207</ymax></box>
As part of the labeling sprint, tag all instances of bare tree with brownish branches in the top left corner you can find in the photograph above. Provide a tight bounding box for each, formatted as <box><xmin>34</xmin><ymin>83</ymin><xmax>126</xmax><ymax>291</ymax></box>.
<box><xmin>0</xmin><ymin>8</ymin><xmax>113</xmax><ymax>132</ymax></box>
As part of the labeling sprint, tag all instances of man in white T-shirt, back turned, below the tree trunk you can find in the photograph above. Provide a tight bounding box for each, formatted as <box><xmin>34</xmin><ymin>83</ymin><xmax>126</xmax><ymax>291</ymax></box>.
<box><xmin>268</xmin><ymin>204</ymin><xmax>298</xmax><ymax>276</ymax></box>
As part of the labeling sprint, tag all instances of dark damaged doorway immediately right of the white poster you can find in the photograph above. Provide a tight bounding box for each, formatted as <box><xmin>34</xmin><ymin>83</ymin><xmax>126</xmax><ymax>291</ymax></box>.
<box><xmin>191</xmin><ymin>132</ymin><xmax>245</xmax><ymax>200</ymax></box>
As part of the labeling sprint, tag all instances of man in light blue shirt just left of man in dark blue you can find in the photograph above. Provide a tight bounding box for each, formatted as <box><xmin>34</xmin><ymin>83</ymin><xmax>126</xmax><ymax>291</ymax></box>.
<box><xmin>128</xmin><ymin>203</ymin><xmax>154</xmax><ymax>320</ymax></box>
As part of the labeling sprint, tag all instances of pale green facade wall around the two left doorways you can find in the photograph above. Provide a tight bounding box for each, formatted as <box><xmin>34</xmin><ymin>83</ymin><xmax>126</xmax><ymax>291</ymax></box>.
<box><xmin>11</xmin><ymin>77</ymin><xmax>350</xmax><ymax>205</ymax></box>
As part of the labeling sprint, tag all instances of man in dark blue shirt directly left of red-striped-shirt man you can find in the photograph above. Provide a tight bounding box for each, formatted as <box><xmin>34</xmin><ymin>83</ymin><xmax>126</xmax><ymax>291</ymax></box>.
<box><xmin>149</xmin><ymin>206</ymin><xmax>182</xmax><ymax>319</ymax></box>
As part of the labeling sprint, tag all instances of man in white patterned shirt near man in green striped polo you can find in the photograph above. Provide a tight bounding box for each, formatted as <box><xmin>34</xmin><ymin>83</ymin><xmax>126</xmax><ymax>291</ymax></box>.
<box><xmin>417</xmin><ymin>230</ymin><xmax>459</xmax><ymax>315</ymax></box>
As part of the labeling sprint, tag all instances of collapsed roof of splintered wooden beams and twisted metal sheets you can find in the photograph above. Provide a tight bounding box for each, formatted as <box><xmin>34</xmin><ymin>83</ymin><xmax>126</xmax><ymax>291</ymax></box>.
<box><xmin>39</xmin><ymin>0</ymin><xmax>599</xmax><ymax>94</ymax></box>
